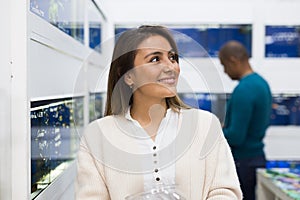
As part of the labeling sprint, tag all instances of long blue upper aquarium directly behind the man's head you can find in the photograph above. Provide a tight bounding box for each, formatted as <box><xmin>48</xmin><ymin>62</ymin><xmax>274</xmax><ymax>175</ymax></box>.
<box><xmin>115</xmin><ymin>24</ymin><xmax>252</xmax><ymax>58</ymax></box>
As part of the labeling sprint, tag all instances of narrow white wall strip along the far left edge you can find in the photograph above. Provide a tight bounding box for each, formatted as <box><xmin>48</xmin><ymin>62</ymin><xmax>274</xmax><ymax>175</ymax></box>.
<box><xmin>0</xmin><ymin>1</ymin><xmax>12</xmax><ymax>199</ymax></box>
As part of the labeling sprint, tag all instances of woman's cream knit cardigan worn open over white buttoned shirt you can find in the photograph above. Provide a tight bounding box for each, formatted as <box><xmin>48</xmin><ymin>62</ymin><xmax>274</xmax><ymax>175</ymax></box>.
<box><xmin>76</xmin><ymin>109</ymin><xmax>242</xmax><ymax>200</ymax></box>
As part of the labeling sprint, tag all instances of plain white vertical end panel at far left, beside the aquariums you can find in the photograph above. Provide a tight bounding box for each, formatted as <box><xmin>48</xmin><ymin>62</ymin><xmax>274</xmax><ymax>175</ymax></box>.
<box><xmin>0</xmin><ymin>0</ymin><xmax>30</xmax><ymax>199</ymax></box>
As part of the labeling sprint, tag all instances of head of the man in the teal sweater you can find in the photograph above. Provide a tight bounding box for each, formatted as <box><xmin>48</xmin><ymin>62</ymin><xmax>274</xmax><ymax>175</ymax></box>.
<box><xmin>219</xmin><ymin>40</ymin><xmax>252</xmax><ymax>80</ymax></box>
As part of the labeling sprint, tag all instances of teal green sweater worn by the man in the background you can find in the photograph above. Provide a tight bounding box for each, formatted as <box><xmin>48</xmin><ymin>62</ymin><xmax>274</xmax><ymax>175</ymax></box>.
<box><xmin>223</xmin><ymin>73</ymin><xmax>272</xmax><ymax>159</ymax></box>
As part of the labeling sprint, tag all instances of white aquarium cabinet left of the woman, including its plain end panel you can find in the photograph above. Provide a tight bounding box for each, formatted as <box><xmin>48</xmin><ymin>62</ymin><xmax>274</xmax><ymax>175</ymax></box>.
<box><xmin>0</xmin><ymin>0</ymin><xmax>110</xmax><ymax>199</ymax></box>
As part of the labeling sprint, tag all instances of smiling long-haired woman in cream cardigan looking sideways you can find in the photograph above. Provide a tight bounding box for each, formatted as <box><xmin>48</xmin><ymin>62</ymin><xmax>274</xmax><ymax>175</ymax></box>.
<box><xmin>76</xmin><ymin>26</ymin><xmax>242</xmax><ymax>200</ymax></box>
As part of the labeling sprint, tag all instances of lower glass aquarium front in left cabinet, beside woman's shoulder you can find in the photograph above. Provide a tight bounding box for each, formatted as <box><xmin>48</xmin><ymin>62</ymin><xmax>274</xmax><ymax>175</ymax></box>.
<box><xmin>30</xmin><ymin>97</ymin><xmax>84</xmax><ymax>198</ymax></box>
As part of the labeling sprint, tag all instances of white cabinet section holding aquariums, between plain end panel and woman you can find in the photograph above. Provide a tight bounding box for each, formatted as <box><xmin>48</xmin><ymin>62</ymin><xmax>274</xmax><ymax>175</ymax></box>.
<box><xmin>27</xmin><ymin>0</ymin><xmax>110</xmax><ymax>199</ymax></box>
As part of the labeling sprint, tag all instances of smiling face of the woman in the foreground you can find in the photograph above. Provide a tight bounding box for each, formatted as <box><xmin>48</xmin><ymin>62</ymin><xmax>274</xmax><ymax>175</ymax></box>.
<box><xmin>131</xmin><ymin>35</ymin><xmax>180</xmax><ymax>98</ymax></box>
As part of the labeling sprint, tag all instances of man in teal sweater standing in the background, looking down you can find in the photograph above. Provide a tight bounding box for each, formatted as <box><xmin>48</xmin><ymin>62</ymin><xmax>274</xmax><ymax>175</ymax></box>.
<box><xmin>219</xmin><ymin>41</ymin><xmax>272</xmax><ymax>200</ymax></box>
